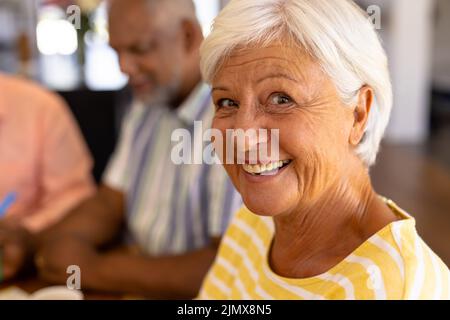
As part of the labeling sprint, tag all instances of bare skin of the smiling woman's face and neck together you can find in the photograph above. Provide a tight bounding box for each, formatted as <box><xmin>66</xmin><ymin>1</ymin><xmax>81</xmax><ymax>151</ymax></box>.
<box><xmin>213</xmin><ymin>45</ymin><xmax>395</xmax><ymax>277</ymax></box>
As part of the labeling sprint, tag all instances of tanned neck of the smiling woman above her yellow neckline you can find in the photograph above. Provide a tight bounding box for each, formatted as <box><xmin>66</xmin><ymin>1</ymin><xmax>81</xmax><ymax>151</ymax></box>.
<box><xmin>269</xmin><ymin>161</ymin><xmax>396</xmax><ymax>278</ymax></box>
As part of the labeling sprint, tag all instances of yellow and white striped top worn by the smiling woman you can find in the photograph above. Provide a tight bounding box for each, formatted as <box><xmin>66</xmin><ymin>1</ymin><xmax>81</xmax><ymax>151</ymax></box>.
<box><xmin>199</xmin><ymin>199</ymin><xmax>450</xmax><ymax>299</ymax></box>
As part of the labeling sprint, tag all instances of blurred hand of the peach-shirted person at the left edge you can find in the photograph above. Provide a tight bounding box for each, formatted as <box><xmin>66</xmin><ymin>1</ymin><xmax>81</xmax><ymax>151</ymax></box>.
<box><xmin>0</xmin><ymin>222</ymin><xmax>34</xmax><ymax>280</ymax></box>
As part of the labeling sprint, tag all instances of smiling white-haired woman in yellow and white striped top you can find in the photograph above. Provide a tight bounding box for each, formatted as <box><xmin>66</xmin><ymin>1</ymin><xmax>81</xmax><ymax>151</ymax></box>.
<box><xmin>199</xmin><ymin>0</ymin><xmax>450</xmax><ymax>299</ymax></box>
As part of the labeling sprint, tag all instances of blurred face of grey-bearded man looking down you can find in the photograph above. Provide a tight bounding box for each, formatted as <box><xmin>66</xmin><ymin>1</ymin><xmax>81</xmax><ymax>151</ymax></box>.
<box><xmin>109</xmin><ymin>0</ymin><xmax>184</xmax><ymax>103</ymax></box>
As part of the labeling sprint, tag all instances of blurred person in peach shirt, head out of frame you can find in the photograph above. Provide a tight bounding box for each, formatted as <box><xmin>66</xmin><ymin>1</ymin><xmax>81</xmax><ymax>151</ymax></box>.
<box><xmin>0</xmin><ymin>74</ymin><xmax>95</xmax><ymax>279</ymax></box>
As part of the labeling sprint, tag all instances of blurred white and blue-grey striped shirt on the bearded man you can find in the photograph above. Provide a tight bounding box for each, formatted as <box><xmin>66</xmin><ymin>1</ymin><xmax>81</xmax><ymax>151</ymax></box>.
<box><xmin>103</xmin><ymin>84</ymin><xmax>242</xmax><ymax>255</ymax></box>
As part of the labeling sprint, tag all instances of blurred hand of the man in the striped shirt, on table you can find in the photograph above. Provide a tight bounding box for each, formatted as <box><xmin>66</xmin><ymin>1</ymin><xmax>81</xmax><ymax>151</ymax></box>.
<box><xmin>35</xmin><ymin>235</ymin><xmax>100</xmax><ymax>287</ymax></box>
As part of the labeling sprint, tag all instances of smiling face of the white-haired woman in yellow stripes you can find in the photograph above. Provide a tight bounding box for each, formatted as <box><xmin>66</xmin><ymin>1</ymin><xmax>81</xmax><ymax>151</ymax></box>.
<box><xmin>212</xmin><ymin>45</ymin><xmax>362</xmax><ymax>216</ymax></box>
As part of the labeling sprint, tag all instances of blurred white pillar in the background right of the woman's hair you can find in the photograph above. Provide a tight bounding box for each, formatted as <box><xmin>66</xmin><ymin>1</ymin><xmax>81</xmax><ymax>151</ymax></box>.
<box><xmin>386</xmin><ymin>0</ymin><xmax>433</xmax><ymax>143</ymax></box>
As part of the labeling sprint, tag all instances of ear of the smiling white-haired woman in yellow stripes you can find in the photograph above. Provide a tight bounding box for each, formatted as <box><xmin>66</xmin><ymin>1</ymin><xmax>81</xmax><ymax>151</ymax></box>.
<box><xmin>349</xmin><ymin>85</ymin><xmax>374</xmax><ymax>146</ymax></box>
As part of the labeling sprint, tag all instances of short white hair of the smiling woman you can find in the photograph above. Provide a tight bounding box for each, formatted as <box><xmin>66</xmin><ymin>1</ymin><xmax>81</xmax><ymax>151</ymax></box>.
<box><xmin>201</xmin><ymin>0</ymin><xmax>392</xmax><ymax>166</ymax></box>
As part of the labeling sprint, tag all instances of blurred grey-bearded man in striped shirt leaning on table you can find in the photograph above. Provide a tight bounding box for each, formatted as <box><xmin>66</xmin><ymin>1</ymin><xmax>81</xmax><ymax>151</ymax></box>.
<box><xmin>29</xmin><ymin>0</ymin><xmax>241</xmax><ymax>298</ymax></box>
